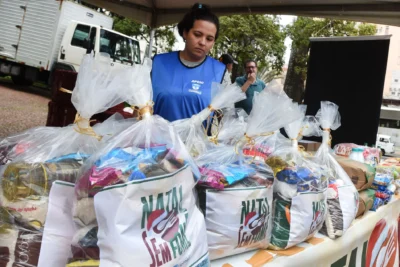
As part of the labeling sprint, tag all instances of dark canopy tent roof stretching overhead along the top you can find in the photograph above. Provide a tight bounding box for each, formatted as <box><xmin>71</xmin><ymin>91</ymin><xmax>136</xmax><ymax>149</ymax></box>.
<box><xmin>83</xmin><ymin>0</ymin><xmax>400</xmax><ymax>28</ymax></box>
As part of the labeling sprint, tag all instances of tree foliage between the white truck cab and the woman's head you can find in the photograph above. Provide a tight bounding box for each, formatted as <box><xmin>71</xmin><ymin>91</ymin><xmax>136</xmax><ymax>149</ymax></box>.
<box><xmin>114</xmin><ymin>16</ymin><xmax>176</xmax><ymax>52</ymax></box>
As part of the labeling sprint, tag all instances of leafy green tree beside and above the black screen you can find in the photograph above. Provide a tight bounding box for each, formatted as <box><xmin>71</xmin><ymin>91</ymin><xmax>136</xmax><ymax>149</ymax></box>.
<box><xmin>284</xmin><ymin>17</ymin><xmax>376</xmax><ymax>102</ymax></box>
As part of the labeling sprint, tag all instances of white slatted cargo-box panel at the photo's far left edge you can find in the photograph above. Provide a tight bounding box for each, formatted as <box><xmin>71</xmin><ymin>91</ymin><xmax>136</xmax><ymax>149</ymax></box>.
<box><xmin>0</xmin><ymin>0</ymin><xmax>27</xmax><ymax>59</ymax></box>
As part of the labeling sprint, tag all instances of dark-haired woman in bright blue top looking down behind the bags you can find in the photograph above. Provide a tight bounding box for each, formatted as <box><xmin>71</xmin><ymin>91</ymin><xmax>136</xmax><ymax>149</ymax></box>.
<box><xmin>151</xmin><ymin>4</ymin><xmax>226</xmax><ymax>121</ymax></box>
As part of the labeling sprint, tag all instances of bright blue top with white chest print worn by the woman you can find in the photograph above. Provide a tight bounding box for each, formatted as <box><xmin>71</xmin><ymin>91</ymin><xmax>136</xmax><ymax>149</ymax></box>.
<box><xmin>151</xmin><ymin>52</ymin><xmax>226</xmax><ymax>121</ymax></box>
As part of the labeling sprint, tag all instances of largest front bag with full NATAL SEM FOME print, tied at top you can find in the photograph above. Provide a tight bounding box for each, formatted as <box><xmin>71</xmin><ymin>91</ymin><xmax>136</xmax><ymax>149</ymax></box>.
<box><xmin>70</xmin><ymin>59</ymin><xmax>209</xmax><ymax>266</ymax></box>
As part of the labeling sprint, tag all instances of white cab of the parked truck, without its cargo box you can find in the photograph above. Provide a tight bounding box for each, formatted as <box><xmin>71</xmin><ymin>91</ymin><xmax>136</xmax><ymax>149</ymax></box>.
<box><xmin>55</xmin><ymin>21</ymin><xmax>141</xmax><ymax>72</ymax></box>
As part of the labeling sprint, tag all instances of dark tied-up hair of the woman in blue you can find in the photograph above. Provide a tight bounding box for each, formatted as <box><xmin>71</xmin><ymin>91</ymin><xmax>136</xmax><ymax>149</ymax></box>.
<box><xmin>178</xmin><ymin>3</ymin><xmax>219</xmax><ymax>39</ymax></box>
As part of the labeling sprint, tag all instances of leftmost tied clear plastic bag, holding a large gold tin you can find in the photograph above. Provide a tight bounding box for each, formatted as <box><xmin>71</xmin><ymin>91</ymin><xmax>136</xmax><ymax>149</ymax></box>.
<box><xmin>0</xmin><ymin>52</ymin><xmax>130</xmax><ymax>266</ymax></box>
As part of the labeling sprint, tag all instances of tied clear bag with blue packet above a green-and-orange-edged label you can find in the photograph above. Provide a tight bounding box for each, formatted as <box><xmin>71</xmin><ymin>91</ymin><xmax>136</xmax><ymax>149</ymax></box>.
<box><xmin>266</xmin><ymin>105</ymin><xmax>327</xmax><ymax>250</ymax></box>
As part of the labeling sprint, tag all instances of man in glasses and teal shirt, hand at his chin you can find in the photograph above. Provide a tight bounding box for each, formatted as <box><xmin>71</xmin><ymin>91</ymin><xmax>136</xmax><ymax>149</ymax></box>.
<box><xmin>235</xmin><ymin>60</ymin><xmax>265</xmax><ymax>114</ymax></box>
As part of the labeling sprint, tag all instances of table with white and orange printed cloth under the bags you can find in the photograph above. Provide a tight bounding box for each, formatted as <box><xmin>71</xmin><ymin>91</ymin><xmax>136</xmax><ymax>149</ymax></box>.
<box><xmin>211</xmin><ymin>197</ymin><xmax>400</xmax><ymax>267</ymax></box>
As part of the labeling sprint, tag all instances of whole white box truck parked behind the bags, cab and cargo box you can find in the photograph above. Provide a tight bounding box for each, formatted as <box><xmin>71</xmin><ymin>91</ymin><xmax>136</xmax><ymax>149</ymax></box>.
<box><xmin>0</xmin><ymin>0</ymin><xmax>140</xmax><ymax>85</ymax></box>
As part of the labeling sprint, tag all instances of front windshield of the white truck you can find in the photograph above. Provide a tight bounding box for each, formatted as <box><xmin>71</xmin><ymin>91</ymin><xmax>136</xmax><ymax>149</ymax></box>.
<box><xmin>100</xmin><ymin>29</ymin><xmax>140</xmax><ymax>64</ymax></box>
